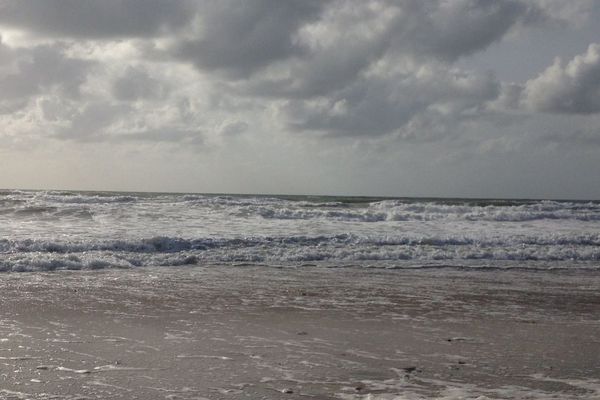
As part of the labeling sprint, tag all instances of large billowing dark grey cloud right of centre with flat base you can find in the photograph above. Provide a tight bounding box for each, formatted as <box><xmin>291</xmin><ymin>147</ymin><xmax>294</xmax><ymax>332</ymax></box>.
<box><xmin>189</xmin><ymin>0</ymin><xmax>530</xmax><ymax>140</ymax></box>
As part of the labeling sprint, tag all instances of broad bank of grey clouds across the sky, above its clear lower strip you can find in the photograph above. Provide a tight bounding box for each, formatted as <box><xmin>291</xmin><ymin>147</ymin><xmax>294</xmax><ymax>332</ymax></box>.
<box><xmin>0</xmin><ymin>0</ymin><xmax>600</xmax><ymax>156</ymax></box>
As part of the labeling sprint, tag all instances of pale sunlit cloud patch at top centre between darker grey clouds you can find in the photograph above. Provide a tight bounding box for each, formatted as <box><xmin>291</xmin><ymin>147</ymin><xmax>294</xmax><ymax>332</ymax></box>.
<box><xmin>237</xmin><ymin>1</ymin><xmax>397</xmax><ymax>98</ymax></box>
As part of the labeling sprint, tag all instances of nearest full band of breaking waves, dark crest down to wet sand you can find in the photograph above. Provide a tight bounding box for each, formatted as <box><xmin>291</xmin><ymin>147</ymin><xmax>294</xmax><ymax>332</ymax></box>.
<box><xmin>0</xmin><ymin>234</ymin><xmax>600</xmax><ymax>271</ymax></box>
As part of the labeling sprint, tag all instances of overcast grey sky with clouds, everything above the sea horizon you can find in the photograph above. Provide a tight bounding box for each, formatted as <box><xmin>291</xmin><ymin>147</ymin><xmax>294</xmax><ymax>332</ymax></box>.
<box><xmin>0</xmin><ymin>0</ymin><xmax>600</xmax><ymax>199</ymax></box>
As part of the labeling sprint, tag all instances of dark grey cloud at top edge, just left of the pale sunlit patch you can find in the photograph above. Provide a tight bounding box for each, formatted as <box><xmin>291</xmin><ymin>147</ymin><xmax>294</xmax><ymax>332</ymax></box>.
<box><xmin>174</xmin><ymin>0</ymin><xmax>328</xmax><ymax>78</ymax></box>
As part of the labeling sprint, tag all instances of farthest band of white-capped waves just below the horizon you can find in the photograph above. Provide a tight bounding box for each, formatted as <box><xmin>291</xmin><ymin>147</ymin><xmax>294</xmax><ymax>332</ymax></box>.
<box><xmin>0</xmin><ymin>191</ymin><xmax>600</xmax><ymax>223</ymax></box>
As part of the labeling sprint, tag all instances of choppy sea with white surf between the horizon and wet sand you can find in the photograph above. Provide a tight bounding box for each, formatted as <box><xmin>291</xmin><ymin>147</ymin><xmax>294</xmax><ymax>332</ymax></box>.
<box><xmin>0</xmin><ymin>190</ymin><xmax>600</xmax><ymax>272</ymax></box>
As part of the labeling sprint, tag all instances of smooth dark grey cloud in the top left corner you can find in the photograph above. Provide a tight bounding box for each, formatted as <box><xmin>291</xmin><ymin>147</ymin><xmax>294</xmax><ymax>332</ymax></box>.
<box><xmin>0</xmin><ymin>0</ymin><xmax>194</xmax><ymax>38</ymax></box>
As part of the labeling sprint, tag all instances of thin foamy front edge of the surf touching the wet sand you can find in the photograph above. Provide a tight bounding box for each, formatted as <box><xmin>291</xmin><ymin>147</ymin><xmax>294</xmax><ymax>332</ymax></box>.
<box><xmin>0</xmin><ymin>252</ymin><xmax>600</xmax><ymax>272</ymax></box>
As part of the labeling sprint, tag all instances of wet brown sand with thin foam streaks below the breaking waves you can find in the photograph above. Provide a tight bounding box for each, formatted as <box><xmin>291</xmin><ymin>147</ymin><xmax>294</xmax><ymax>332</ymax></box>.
<box><xmin>0</xmin><ymin>266</ymin><xmax>600</xmax><ymax>400</ymax></box>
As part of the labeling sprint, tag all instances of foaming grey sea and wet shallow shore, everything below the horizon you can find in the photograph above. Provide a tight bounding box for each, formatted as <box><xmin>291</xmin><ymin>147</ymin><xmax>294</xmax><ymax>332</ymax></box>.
<box><xmin>0</xmin><ymin>190</ymin><xmax>600</xmax><ymax>400</ymax></box>
